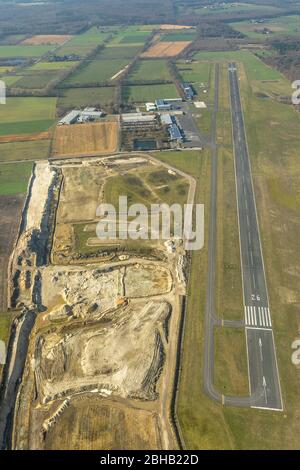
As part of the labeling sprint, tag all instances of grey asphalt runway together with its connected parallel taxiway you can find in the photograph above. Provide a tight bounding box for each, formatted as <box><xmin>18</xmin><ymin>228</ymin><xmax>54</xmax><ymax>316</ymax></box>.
<box><xmin>203</xmin><ymin>64</ymin><xmax>282</xmax><ymax>411</ymax></box>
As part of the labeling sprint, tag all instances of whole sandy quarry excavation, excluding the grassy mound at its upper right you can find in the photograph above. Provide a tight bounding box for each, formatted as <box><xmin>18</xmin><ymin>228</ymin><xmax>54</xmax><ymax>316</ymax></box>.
<box><xmin>11</xmin><ymin>159</ymin><xmax>180</xmax><ymax>449</ymax></box>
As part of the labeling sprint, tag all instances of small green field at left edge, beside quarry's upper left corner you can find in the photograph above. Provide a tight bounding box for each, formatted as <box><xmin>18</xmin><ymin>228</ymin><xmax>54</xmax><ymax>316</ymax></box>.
<box><xmin>0</xmin><ymin>162</ymin><xmax>33</xmax><ymax>195</ymax></box>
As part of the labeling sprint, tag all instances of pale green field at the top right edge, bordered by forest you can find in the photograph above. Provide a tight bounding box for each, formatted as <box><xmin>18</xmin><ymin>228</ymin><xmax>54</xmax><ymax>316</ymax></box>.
<box><xmin>230</xmin><ymin>15</ymin><xmax>300</xmax><ymax>40</ymax></box>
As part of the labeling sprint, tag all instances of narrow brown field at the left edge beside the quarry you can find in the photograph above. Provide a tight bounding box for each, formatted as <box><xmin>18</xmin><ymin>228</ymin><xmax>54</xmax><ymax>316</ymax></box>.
<box><xmin>0</xmin><ymin>194</ymin><xmax>24</xmax><ymax>312</ymax></box>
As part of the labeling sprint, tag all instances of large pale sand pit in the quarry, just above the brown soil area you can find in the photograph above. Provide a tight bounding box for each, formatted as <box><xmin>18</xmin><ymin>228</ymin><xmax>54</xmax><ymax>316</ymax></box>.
<box><xmin>34</xmin><ymin>301</ymin><xmax>170</xmax><ymax>404</ymax></box>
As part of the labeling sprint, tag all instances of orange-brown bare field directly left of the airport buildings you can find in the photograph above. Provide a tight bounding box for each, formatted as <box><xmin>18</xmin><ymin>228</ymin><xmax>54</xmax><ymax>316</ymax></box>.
<box><xmin>53</xmin><ymin>122</ymin><xmax>119</xmax><ymax>156</ymax></box>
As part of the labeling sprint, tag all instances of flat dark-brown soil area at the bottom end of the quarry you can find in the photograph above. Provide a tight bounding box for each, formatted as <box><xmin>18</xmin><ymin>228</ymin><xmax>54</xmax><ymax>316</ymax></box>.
<box><xmin>45</xmin><ymin>398</ymin><xmax>161</xmax><ymax>450</ymax></box>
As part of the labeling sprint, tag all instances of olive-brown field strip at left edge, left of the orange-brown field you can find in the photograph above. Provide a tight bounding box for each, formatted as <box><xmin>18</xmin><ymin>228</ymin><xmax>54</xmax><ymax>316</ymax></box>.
<box><xmin>0</xmin><ymin>140</ymin><xmax>50</xmax><ymax>163</ymax></box>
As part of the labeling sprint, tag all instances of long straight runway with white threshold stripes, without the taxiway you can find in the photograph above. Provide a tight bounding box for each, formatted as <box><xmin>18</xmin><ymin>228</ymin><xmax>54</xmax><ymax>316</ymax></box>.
<box><xmin>229</xmin><ymin>64</ymin><xmax>283</xmax><ymax>410</ymax></box>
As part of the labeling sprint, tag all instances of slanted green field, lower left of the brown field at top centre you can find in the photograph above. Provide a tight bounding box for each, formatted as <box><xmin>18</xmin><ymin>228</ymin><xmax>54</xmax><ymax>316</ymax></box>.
<box><xmin>64</xmin><ymin>59</ymin><xmax>128</xmax><ymax>85</ymax></box>
